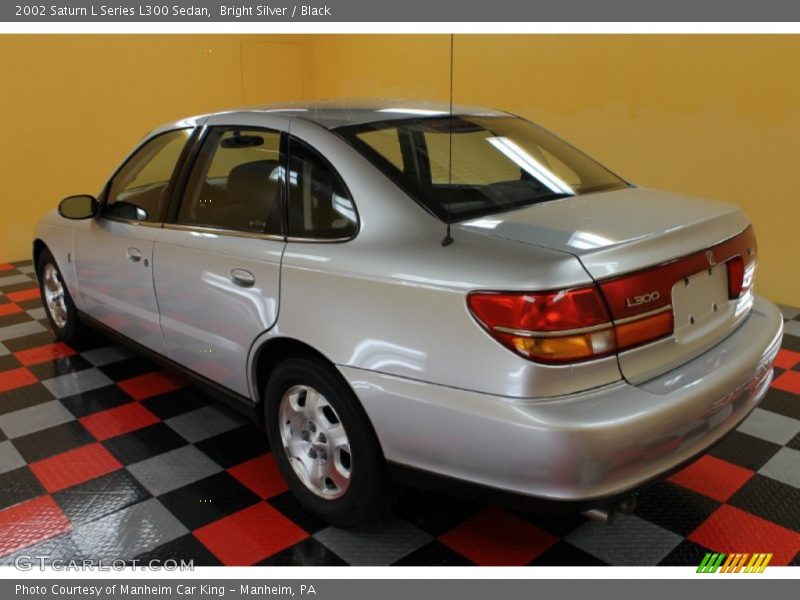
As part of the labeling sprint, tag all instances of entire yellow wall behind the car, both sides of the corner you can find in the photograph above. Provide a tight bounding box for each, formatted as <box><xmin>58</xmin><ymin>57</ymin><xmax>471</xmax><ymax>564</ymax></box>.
<box><xmin>0</xmin><ymin>35</ymin><xmax>800</xmax><ymax>306</ymax></box>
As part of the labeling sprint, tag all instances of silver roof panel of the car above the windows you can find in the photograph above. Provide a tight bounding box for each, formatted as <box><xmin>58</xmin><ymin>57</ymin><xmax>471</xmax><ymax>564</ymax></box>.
<box><xmin>153</xmin><ymin>99</ymin><xmax>509</xmax><ymax>130</ymax></box>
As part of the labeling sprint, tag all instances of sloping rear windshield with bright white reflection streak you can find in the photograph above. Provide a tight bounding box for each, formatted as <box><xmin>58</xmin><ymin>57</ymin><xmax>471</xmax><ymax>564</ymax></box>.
<box><xmin>336</xmin><ymin>115</ymin><xmax>628</xmax><ymax>222</ymax></box>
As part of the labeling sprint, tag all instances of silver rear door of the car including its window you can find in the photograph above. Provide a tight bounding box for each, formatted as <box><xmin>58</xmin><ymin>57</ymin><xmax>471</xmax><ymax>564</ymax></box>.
<box><xmin>153</xmin><ymin>114</ymin><xmax>288</xmax><ymax>396</ymax></box>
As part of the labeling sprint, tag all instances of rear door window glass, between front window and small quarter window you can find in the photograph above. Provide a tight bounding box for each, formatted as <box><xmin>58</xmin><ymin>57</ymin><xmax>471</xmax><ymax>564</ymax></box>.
<box><xmin>178</xmin><ymin>127</ymin><xmax>284</xmax><ymax>235</ymax></box>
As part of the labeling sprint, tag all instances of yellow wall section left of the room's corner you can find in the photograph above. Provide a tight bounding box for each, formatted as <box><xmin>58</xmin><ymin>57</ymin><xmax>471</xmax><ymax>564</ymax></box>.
<box><xmin>0</xmin><ymin>35</ymin><xmax>313</xmax><ymax>262</ymax></box>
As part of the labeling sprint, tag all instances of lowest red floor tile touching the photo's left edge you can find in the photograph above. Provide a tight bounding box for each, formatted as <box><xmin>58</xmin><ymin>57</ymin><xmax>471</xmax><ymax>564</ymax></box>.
<box><xmin>0</xmin><ymin>496</ymin><xmax>71</xmax><ymax>556</ymax></box>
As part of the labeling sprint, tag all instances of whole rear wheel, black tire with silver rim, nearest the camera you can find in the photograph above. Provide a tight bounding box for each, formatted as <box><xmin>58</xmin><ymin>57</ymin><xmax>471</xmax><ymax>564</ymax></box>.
<box><xmin>264</xmin><ymin>357</ymin><xmax>391</xmax><ymax>527</ymax></box>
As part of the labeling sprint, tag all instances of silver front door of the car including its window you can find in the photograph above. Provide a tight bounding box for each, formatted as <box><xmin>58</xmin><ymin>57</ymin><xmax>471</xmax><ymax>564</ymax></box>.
<box><xmin>75</xmin><ymin>129</ymin><xmax>192</xmax><ymax>354</ymax></box>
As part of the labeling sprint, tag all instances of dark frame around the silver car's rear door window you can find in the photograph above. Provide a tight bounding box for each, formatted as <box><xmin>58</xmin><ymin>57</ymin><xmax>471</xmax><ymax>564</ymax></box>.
<box><xmin>169</xmin><ymin>123</ymin><xmax>289</xmax><ymax>241</ymax></box>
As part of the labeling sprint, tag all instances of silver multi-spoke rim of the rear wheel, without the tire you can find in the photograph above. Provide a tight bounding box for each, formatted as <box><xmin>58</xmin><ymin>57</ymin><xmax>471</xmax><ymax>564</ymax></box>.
<box><xmin>278</xmin><ymin>385</ymin><xmax>352</xmax><ymax>500</ymax></box>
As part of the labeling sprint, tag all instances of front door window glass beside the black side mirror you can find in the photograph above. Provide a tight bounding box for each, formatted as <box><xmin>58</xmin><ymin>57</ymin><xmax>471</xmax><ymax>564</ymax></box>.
<box><xmin>103</xmin><ymin>129</ymin><xmax>192</xmax><ymax>223</ymax></box>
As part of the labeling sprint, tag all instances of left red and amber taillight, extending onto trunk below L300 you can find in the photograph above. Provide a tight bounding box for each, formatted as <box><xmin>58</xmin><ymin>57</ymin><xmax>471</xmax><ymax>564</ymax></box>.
<box><xmin>467</xmin><ymin>286</ymin><xmax>673</xmax><ymax>364</ymax></box>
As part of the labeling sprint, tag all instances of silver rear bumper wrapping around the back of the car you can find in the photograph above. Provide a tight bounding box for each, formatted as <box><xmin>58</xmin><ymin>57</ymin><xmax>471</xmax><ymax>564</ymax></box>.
<box><xmin>339</xmin><ymin>298</ymin><xmax>783</xmax><ymax>502</ymax></box>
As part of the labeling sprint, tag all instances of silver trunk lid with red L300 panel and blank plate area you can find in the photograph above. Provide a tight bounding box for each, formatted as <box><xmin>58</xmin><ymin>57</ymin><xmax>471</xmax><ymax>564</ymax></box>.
<box><xmin>455</xmin><ymin>188</ymin><xmax>756</xmax><ymax>383</ymax></box>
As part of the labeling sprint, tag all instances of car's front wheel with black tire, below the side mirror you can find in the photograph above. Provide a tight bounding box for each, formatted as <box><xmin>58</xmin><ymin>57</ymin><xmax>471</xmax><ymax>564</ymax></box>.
<box><xmin>36</xmin><ymin>248</ymin><xmax>84</xmax><ymax>344</ymax></box>
